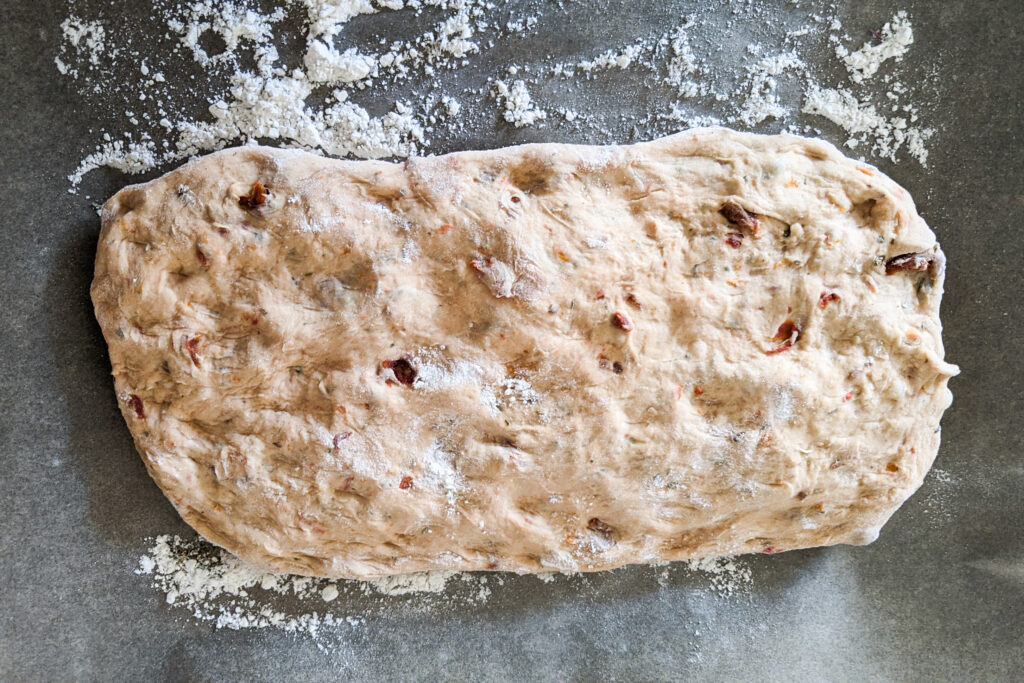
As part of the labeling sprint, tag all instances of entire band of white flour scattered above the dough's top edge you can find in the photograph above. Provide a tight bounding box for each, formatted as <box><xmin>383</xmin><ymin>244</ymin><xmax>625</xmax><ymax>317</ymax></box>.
<box><xmin>54</xmin><ymin>0</ymin><xmax>935</xmax><ymax>191</ymax></box>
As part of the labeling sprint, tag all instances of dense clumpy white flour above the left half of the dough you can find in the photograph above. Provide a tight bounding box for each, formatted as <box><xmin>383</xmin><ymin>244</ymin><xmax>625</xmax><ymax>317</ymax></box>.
<box><xmin>55</xmin><ymin>0</ymin><xmax>495</xmax><ymax>187</ymax></box>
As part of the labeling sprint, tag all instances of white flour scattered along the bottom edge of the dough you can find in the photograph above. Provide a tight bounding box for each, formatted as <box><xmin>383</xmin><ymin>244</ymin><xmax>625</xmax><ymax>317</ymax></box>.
<box><xmin>135</xmin><ymin>535</ymin><xmax>752</xmax><ymax>634</ymax></box>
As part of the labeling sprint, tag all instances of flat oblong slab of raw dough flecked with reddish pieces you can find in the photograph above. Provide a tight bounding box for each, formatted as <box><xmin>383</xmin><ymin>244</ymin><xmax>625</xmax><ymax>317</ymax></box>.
<box><xmin>92</xmin><ymin>129</ymin><xmax>956</xmax><ymax>578</ymax></box>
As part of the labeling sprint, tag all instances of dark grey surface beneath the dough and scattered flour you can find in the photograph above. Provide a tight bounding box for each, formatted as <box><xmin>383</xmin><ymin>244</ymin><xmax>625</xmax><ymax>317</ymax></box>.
<box><xmin>0</xmin><ymin>0</ymin><xmax>1024</xmax><ymax>681</ymax></box>
